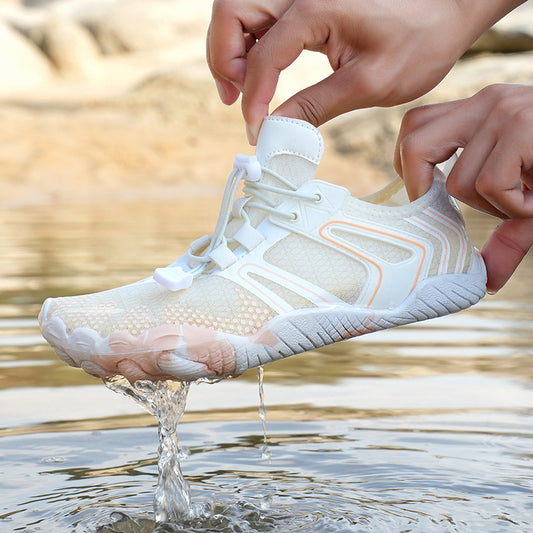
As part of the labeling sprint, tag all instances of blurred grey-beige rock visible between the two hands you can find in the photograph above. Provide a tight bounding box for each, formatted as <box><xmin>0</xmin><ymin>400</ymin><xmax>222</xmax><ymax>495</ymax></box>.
<box><xmin>327</xmin><ymin>52</ymin><xmax>533</xmax><ymax>176</ymax></box>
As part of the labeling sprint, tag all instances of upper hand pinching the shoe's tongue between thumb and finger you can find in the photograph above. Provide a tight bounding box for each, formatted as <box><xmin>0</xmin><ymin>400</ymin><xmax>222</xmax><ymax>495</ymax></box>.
<box><xmin>207</xmin><ymin>0</ymin><xmax>523</xmax><ymax>144</ymax></box>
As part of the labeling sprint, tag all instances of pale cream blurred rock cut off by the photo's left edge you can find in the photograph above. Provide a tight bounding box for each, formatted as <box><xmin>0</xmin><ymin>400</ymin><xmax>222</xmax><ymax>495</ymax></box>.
<box><xmin>0</xmin><ymin>23</ymin><xmax>53</xmax><ymax>96</ymax></box>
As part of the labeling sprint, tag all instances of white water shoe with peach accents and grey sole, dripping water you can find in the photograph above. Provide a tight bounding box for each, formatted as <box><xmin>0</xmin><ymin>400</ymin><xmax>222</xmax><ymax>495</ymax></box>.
<box><xmin>39</xmin><ymin>117</ymin><xmax>486</xmax><ymax>382</ymax></box>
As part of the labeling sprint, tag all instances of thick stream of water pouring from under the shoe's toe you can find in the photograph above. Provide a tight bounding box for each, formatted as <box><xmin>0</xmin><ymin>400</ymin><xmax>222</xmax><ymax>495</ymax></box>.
<box><xmin>105</xmin><ymin>376</ymin><xmax>209</xmax><ymax>523</ymax></box>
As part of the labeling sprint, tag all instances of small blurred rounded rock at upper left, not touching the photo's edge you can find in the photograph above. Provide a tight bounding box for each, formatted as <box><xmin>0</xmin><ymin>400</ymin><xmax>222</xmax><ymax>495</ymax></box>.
<box><xmin>31</xmin><ymin>17</ymin><xmax>100</xmax><ymax>79</ymax></box>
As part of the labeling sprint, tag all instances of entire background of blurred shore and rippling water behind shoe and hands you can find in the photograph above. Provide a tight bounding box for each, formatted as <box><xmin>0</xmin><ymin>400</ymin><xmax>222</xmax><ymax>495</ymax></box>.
<box><xmin>0</xmin><ymin>0</ymin><xmax>533</xmax><ymax>533</ymax></box>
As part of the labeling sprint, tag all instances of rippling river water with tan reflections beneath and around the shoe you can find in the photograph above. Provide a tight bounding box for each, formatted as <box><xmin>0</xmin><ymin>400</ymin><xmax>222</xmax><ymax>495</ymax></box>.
<box><xmin>0</xmin><ymin>196</ymin><xmax>533</xmax><ymax>533</ymax></box>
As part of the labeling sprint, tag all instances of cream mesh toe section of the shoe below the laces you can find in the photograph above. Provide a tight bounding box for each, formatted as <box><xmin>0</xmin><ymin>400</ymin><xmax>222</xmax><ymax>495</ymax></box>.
<box><xmin>49</xmin><ymin>276</ymin><xmax>275</xmax><ymax>336</ymax></box>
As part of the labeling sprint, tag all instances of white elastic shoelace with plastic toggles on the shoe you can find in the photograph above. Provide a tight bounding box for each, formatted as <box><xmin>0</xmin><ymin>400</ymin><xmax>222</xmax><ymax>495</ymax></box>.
<box><xmin>153</xmin><ymin>154</ymin><xmax>321</xmax><ymax>291</ymax></box>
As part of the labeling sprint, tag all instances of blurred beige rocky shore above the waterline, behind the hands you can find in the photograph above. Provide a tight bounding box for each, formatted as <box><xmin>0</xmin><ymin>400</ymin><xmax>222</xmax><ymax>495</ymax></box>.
<box><xmin>0</xmin><ymin>0</ymin><xmax>533</xmax><ymax>207</ymax></box>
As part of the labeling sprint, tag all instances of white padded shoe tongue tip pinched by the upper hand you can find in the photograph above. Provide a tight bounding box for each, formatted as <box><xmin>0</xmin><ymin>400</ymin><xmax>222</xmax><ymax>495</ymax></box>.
<box><xmin>255</xmin><ymin>116</ymin><xmax>324</xmax><ymax>187</ymax></box>
